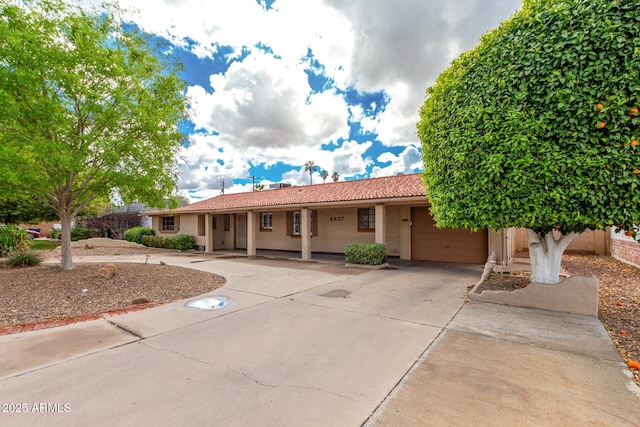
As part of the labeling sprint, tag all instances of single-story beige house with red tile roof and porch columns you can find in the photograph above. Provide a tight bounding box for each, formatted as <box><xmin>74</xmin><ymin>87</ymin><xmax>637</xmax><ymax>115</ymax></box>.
<box><xmin>145</xmin><ymin>174</ymin><xmax>505</xmax><ymax>264</ymax></box>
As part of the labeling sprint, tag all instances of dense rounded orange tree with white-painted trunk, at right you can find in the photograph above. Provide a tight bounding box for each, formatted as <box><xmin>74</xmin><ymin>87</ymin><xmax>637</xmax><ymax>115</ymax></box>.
<box><xmin>418</xmin><ymin>0</ymin><xmax>640</xmax><ymax>283</ymax></box>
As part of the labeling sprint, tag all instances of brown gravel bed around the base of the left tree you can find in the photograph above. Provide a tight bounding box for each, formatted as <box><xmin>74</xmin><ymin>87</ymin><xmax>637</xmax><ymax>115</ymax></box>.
<box><xmin>0</xmin><ymin>248</ymin><xmax>224</xmax><ymax>325</ymax></box>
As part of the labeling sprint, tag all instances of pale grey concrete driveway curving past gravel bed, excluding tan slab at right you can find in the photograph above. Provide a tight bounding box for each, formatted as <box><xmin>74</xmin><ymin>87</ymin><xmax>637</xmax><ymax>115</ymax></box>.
<box><xmin>0</xmin><ymin>256</ymin><xmax>480</xmax><ymax>426</ymax></box>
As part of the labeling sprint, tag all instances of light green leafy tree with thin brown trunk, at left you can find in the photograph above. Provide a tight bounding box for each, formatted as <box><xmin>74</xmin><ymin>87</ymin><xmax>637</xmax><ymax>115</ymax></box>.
<box><xmin>0</xmin><ymin>0</ymin><xmax>186</xmax><ymax>270</ymax></box>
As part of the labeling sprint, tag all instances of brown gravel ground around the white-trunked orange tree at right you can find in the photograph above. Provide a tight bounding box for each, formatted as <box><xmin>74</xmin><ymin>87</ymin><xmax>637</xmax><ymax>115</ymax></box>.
<box><xmin>479</xmin><ymin>254</ymin><xmax>640</xmax><ymax>386</ymax></box>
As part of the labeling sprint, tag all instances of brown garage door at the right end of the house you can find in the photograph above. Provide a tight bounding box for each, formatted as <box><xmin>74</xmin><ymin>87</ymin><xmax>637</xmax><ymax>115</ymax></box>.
<box><xmin>411</xmin><ymin>207</ymin><xmax>488</xmax><ymax>264</ymax></box>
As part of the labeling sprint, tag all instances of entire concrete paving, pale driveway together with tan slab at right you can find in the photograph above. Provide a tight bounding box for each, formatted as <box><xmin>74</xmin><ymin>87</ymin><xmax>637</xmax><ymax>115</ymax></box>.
<box><xmin>0</xmin><ymin>255</ymin><xmax>640</xmax><ymax>426</ymax></box>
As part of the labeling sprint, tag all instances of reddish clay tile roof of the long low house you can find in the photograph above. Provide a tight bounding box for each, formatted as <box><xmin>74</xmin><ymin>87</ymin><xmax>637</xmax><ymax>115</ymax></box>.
<box><xmin>151</xmin><ymin>174</ymin><xmax>426</xmax><ymax>214</ymax></box>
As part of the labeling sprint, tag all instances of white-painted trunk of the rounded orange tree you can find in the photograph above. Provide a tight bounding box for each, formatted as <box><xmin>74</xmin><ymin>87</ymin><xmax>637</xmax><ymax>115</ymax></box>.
<box><xmin>527</xmin><ymin>228</ymin><xmax>579</xmax><ymax>284</ymax></box>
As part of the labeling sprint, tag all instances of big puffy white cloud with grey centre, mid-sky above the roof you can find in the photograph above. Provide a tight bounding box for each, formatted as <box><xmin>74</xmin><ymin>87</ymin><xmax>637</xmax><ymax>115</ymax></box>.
<box><xmin>187</xmin><ymin>50</ymin><xmax>349</xmax><ymax>150</ymax></box>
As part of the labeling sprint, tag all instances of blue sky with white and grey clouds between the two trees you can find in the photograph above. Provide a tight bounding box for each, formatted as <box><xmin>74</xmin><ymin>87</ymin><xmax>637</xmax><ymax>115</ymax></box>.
<box><xmin>92</xmin><ymin>0</ymin><xmax>521</xmax><ymax>202</ymax></box>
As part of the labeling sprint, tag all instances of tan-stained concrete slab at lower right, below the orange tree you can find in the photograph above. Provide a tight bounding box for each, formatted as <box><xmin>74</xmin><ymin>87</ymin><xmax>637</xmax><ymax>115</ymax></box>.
<box><xmin>367</xmin><ymin>303</ymin><xmax>640</xmax><ymax>427</ymax></box>
